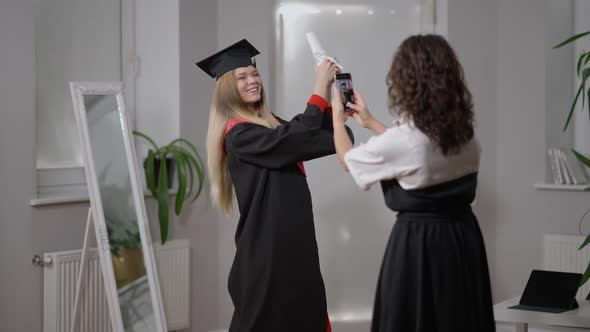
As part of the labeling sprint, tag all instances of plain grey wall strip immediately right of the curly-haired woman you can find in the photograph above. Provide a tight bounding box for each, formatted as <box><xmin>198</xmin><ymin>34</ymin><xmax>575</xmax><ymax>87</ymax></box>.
<box><xmin>447</xmin><ymin>0</ymin><xmax>498</xmax><ymax>298</ymax></box>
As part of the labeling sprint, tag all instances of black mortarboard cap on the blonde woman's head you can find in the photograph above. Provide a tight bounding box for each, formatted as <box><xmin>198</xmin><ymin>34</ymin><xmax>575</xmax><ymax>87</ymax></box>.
<box><xmin>197</xmin><ymin>39</ymin><xmax>260</xmax><ymax>79</ymax></box>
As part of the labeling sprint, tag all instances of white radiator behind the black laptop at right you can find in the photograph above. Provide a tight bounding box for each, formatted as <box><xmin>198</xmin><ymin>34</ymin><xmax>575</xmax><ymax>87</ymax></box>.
<box><xmin>543</xmin><ymin>234</ymin><xmax>590</xmax><ymax>301</ymax></box>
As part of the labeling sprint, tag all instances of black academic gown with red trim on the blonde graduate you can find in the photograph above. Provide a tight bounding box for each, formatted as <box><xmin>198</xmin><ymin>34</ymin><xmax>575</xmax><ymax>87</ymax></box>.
<box><xmin>225</xmin><ymin>97</ymin><xmax>350</xmax><ymax>332</ymax></box>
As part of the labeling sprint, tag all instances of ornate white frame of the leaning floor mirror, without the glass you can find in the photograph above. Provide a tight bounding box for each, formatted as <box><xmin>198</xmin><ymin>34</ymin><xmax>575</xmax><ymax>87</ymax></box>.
<box><xmin>70</xmin><ymin>82</ymin><xmax>168</xmax><ymax>332</ymax></box>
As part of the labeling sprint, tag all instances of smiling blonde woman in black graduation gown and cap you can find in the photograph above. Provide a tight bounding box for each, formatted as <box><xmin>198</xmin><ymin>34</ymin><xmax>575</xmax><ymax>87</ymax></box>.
<box><xmin>197</xmin><ymin>40</ymin><xmax>352</xmax><ymax>332</ymax></box>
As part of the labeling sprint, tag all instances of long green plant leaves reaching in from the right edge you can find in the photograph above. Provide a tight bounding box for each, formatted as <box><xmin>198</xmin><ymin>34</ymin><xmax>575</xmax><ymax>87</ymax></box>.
<box><xmin>553</xmin><ymin>31</ymin><xmax>590</xmax><ymax>292</ymax></box>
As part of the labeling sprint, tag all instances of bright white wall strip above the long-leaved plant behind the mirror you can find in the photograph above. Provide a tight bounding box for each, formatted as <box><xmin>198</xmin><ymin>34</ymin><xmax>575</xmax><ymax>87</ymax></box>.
<box><xmin>135</xmin><ymin>0</ymin><xmax>180</xmax><ymax>147</ymax></box>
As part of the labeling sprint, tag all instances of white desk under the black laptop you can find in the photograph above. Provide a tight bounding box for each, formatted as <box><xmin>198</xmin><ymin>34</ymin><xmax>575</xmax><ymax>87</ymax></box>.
<box><xmin>494</xmin><ymin>296</ymin><xmax>590</xmax><ymax>332</ymax></box>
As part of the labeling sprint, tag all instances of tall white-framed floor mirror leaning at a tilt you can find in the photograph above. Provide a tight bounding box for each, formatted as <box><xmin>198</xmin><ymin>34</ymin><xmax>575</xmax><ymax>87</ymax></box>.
<box><xmin>70</xmin><ymin>82</ymin><xmax>167</xmax><ymax>332</ymax></box>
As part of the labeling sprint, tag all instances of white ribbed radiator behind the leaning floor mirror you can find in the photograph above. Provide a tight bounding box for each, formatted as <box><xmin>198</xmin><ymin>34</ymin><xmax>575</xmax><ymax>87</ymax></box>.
<box><xmin>43</xmin><ymin>240</ymin><xmax>191</xmax><ymax>332</ymax></box>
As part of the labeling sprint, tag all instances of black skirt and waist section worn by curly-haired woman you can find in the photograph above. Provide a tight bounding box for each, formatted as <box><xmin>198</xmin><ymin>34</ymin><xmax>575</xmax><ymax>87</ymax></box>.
<box><xmin>371</xmin><ymin>175</ymin><xmax>495</xmax><ymax>332</ymax></box>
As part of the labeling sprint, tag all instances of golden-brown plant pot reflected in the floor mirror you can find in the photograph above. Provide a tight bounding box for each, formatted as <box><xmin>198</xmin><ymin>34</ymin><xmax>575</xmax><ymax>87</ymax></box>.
<box><xmin>112</xmin><ymin>248</ymin><xmax>145</xmax><ymax>288</ymax></box>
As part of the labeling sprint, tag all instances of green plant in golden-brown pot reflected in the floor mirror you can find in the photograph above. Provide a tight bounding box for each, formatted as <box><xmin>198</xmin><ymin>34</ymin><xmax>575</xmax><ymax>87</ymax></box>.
<box><xmin>107</xmin><ymin>224</ymin><xmax>145</xmax><ymax>288</ymax></box>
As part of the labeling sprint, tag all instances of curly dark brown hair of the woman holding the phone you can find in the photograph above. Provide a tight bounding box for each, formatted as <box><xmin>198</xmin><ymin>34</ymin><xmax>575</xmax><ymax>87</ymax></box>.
<box><xmin>386</xmin><ymin>35</ymin><xmax>474</xmax><ymax>155</ymax></box>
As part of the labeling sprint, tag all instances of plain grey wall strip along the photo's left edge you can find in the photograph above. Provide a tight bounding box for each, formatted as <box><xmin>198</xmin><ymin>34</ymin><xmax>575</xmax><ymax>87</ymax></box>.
<box><xmin>0</xmin><ymin>0</ymin><xmax>40</xmax><ymax>331</ymax></box>
